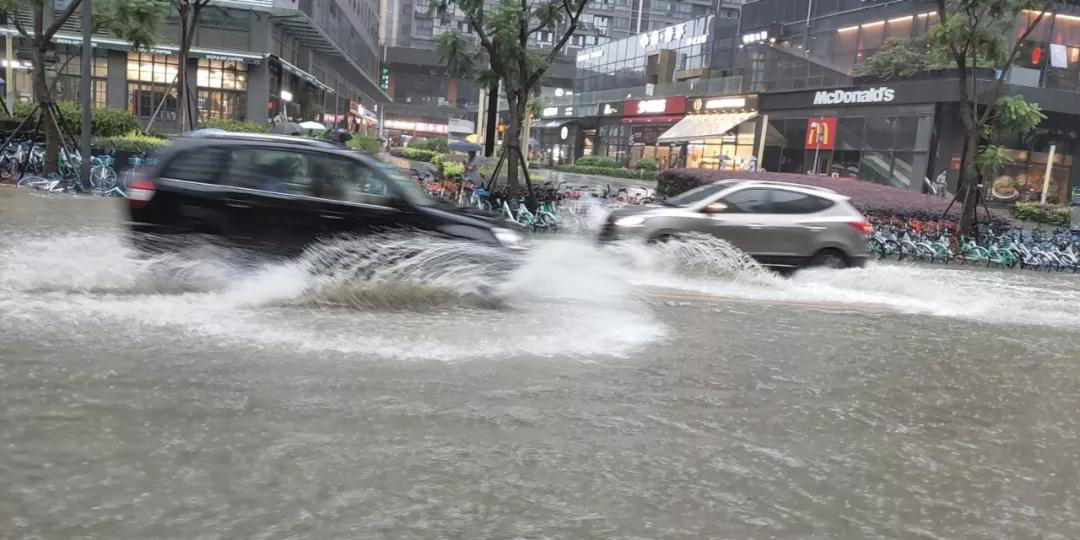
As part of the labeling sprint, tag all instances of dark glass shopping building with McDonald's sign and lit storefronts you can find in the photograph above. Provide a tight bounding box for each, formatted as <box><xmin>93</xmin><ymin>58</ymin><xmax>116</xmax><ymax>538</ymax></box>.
<box><xmin>540</xmin><ymin>0</ymin><xmax>1080</xmax><ymax>202</ymax></box>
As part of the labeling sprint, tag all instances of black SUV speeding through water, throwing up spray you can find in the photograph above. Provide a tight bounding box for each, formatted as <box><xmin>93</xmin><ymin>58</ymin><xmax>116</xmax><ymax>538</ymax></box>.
<box><xmin>127</xmin><ymin>131</ymin><xmax>521</xmax><ymax>255</ymax></box>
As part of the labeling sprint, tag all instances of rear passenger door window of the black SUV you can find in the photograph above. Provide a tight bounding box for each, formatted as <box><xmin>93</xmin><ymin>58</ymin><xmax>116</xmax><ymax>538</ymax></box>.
<box><xmin>225</xmin><ymin>148</ymin><xmax>312</xmax><ymax>195</ymax></box>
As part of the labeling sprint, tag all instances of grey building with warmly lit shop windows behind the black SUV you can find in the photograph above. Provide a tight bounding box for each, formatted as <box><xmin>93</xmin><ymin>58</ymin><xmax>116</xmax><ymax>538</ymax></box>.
<box><xmin>0</xmin><ymin>0</ymin><xmax>389</xmax><ymax>131</ymax></box>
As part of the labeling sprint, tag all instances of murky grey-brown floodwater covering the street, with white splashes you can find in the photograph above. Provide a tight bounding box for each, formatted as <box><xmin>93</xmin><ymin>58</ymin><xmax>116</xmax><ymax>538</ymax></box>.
<box><xmin>0</xmin><ymin>188</ymin><xmax>1080</xmax><ymax>539</ymax></box>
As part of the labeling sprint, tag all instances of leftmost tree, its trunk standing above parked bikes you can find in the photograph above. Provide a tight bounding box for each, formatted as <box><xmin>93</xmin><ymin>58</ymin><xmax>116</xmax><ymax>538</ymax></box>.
<box><xmin>0</xmin><ymin>0</ymin><xmax>163</xmax><ymax>172</ymax></box>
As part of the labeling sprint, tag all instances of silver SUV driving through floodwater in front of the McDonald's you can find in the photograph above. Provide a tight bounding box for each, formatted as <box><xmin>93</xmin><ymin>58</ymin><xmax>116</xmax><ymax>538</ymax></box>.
<box><xmin>600</xmin><ymin>180</ymin><xmax>872</xmax><ymax>269</ymax></box>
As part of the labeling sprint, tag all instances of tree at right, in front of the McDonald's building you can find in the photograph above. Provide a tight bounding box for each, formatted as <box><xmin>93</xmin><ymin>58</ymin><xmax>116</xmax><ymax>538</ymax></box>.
<box><xmin>929</xmin><ymin>0</ymin><xmax>1052</xmax><ymax>232</ymax></box>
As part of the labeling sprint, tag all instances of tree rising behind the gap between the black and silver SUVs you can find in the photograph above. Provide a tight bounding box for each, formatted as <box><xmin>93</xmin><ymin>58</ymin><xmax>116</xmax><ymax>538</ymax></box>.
<box><xmin>431</xmin><ymin>0</ymin><xmax>589</xmax><ymax>205</ymax></box>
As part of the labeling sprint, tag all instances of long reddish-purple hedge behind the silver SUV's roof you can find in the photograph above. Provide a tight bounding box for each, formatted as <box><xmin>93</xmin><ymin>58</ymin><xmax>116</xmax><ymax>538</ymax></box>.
<box><xmin>657</xmin><ymin>168</ymin><xmax>1009</xmax><ymax>220</ymax></box>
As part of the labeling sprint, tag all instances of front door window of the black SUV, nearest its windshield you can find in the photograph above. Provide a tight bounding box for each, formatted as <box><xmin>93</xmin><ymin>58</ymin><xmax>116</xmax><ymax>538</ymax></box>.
<box><xmin>310</xmin><ymin>154</ymin><xmax>394</xmax><ymax>206</ymax></box>
